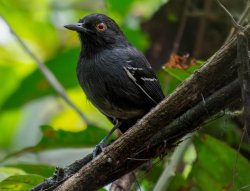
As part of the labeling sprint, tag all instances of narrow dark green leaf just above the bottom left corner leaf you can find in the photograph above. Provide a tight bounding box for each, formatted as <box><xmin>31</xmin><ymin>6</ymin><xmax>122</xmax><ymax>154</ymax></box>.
<box><xmin>8</xmin><ymin>164</ymin><xmax>55</xmax><ymax>177</ymax></box>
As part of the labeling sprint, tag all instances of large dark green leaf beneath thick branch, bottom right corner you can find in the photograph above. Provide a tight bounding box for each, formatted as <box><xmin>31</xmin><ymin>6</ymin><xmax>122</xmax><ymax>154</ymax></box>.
<box><xmin>189</xmin><ymin>135</ymin><xmax>250</xmax><ymax>191</ymax></box>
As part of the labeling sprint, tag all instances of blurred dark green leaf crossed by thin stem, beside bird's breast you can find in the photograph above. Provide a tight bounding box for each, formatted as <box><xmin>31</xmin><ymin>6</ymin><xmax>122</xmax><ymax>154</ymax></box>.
<box><xmin>2</xmin><ymin>49</ymin><xmax>79</xmax><ymax>109</ymax></box>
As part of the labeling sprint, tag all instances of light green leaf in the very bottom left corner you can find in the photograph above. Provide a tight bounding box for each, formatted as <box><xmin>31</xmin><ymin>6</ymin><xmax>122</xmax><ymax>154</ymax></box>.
<box><xmin>0</xmin><ymin>175</ymin><xmax>44</xmax><ymax>191</ymax></box>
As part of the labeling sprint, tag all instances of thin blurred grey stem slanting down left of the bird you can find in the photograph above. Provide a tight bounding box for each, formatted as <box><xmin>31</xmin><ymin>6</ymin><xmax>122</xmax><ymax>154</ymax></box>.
<box><xmin>1</xmin><ymin>16</ymin><xmax>90</xmax><ymax>124</ymax></box>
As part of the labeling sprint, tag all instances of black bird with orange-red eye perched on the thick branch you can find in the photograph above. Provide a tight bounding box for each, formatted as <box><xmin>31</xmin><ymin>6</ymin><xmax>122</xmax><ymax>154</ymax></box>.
<box><xmin>65</xmin><ymin>14</ymin><xmax>164</xmax><ymax>156</ymax></box>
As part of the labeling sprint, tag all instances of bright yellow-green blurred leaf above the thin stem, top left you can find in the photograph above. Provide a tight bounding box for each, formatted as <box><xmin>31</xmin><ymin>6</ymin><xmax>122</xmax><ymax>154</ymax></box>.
<box><xmin>0</xmin><ymin>0</ymin><xmax>59</xmax><ymax>57</ymax></box>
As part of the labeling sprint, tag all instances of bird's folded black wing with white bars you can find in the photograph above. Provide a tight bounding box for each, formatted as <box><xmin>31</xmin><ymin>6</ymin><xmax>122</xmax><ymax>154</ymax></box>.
<box><xmin>123</xmin><ymin>50</ymin><xmax>165</xmax><ymax>105</ymax></box>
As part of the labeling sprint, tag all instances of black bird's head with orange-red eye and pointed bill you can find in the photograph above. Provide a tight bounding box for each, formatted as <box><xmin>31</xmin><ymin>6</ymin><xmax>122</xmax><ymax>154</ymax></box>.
<box><xmin>65</xmin><ymin>14</ymin><xmax>128</xmax><ymax>51</ymax></box>
